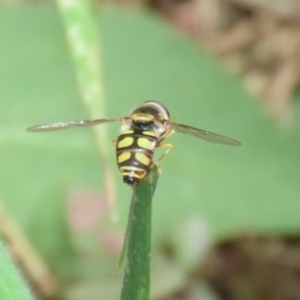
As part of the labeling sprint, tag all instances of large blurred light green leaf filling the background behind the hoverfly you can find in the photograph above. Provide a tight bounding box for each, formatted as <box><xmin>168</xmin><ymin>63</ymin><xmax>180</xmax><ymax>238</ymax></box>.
<box><xmin>0</xmin><ymin>5</ymin><xmax>300</xmax><ymax>300</ymax></box>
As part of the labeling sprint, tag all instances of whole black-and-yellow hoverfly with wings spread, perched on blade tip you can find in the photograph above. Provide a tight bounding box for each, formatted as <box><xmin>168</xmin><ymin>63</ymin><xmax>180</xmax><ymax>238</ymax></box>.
<box><xmin>27</xmin><ymin>100</ymin><xmax>241</xmax><ymax>186</ymax></box>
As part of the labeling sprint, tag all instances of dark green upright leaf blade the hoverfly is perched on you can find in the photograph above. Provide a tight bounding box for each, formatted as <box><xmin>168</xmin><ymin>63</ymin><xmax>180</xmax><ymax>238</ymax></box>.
<box><xmin>121</xmin><ymin>166</ymin><xmax>159</xmax><ymax>300</ymax></box>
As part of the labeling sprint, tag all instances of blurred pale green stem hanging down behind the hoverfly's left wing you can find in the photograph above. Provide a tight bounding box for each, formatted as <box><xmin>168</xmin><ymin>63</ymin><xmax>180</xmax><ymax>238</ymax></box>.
<box><xmin>57</xmin><ymin>0</ymin><xmax>117</xmax><ymax>218</ymax></box>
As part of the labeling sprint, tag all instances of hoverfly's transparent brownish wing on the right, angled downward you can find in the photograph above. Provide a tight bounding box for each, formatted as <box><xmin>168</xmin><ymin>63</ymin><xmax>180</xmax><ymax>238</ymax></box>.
<box><xmin>171</xmin><ymin>123</ymin><xmax>242</xmax><ymax>146</ymax></box>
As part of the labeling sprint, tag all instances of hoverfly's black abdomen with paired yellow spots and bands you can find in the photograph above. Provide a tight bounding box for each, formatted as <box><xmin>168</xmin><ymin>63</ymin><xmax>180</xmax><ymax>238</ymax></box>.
<box><xmin>116</xmin><ymin>130</ymin><xmax>157</xmax><ymax>185</ymax></box>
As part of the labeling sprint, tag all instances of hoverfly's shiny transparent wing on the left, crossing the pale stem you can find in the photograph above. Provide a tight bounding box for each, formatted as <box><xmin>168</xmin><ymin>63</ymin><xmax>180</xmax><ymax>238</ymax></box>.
<box><xmin>26</xmin><ymin>119</ymin><xmax>121</xmax><ymax>132</ymax></box>
